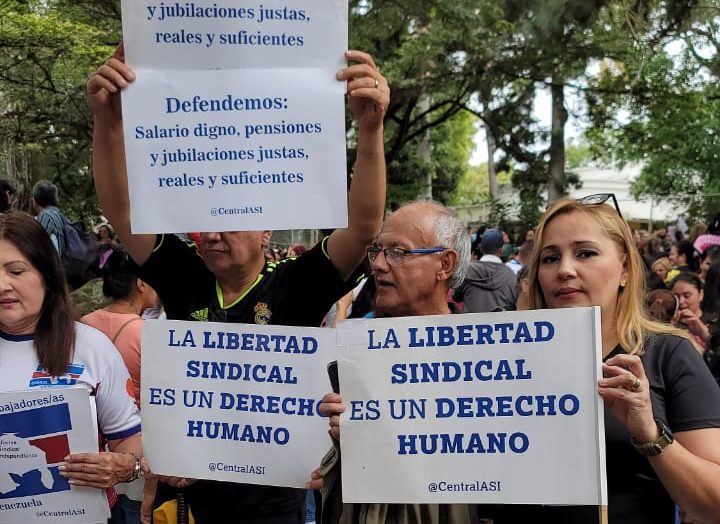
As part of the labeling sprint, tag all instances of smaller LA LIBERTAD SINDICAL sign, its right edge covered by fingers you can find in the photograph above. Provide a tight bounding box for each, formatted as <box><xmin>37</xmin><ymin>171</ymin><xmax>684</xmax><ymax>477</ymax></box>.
<box><xmin>141</xmin><ymin>320</ymin><xmax>336</xmax><ymax>488</ymax></box>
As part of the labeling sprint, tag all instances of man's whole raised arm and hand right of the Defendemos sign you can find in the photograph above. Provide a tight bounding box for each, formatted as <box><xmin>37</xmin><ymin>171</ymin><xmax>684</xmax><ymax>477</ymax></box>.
<box><xmin>328</xmin><ymin>51</ymin><xmax>390</xmax><ymax>279</ymax></box>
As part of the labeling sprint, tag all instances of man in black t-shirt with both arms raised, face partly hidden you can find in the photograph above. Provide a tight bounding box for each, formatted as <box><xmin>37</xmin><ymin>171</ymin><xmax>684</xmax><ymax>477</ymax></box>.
<box><xmin>87</xmin><ymin>46</ymin><xmax>390</xmax><ymax>524</ymax></box>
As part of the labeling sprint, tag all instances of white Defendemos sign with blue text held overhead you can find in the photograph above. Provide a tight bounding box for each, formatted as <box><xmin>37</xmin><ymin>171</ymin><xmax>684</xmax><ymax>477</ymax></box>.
<box><xmin>122</xmin><ymin>0</ymin><xmax>348</xmax><ymax>233</ymax></box>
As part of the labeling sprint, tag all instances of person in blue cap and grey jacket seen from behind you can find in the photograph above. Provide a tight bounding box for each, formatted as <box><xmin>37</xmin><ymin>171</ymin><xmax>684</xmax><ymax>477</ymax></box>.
<box><xmin>453</xmin><ymin>228</ymin><xmax>517</xmax><ymax>313</ymax></box>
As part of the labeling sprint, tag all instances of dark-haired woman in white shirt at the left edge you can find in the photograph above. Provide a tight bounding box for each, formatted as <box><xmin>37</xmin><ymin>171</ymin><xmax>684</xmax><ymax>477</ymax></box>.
<box><xmin>0</xmin><ymin>212</ymin><xmax>142</xmax><ymax>505</ymax></box>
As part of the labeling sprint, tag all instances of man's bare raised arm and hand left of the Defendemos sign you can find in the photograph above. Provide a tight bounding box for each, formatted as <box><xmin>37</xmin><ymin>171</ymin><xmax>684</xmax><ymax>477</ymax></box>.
<box><xmin>87</xmin><ymin>44</ymin><xmax>155</xmax><ymax>265</ymax></box>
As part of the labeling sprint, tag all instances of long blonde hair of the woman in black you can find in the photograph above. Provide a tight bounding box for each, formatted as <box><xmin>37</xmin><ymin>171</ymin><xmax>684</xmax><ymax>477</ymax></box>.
<box><xmin>528</xmin><ymin>198</ymin><xmax>688</xmax><ymax>355</ymax></box>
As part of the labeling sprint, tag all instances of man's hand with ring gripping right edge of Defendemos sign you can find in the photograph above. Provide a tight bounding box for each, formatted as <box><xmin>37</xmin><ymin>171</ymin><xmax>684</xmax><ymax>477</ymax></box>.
<box><xmin>337</xmin><ymin>51</ymin><xmax>390</xmax><ymax>130</ymax></box>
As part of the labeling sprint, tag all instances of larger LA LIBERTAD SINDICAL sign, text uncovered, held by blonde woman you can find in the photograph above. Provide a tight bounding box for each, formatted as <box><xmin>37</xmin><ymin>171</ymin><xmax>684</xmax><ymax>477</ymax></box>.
<box><xmin>338</xmin><ymin>308</ymin><xmax>607</xmax><ymax>505</ymax></box>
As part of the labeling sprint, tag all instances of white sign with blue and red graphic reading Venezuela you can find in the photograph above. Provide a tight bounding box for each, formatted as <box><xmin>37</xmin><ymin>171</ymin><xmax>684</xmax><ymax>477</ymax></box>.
<box><xmin>0</xmin><ymin>387</ymin><xmax>110</xmax><ymax>524</ymax></box>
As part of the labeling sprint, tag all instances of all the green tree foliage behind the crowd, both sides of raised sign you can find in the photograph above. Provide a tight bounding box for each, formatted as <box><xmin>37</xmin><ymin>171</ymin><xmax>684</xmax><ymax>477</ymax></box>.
<box><xmin>0</xmin><ymin>0</ymin><xmax>720</xmax><ymax>226</ymax></box>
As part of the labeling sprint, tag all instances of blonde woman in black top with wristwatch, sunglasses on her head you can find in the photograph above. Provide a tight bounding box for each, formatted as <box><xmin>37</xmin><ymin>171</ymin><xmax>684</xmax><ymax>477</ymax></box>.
<box><xmin>482</xmin><ymin>199</ymin><xmax>720</xmax><ymax>524</ymax></box>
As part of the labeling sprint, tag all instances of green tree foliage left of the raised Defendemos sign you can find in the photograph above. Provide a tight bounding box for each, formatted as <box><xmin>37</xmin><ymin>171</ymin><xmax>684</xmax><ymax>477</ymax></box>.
<box><xmin>0</xmin><ymin>0</ymin><xmax>119</xmax><ymax>214</ymax></box>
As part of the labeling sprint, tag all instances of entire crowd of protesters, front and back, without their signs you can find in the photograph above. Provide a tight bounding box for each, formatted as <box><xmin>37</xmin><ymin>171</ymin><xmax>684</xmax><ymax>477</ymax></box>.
<box><xmin>0</xmin><ymin>39</ymin><xmax>720</xmax><ymax>524</ymax></box>
